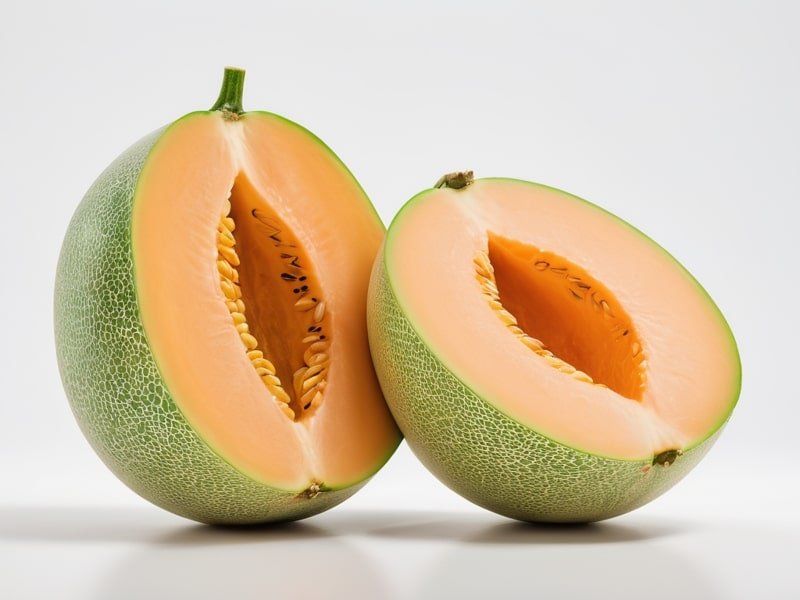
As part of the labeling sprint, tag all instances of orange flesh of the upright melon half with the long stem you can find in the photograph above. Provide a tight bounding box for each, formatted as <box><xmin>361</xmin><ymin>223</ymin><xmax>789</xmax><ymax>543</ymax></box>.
<box><xmin>133</xmin><ymin>113</ymin><xmax>406</xmax><ymax>491</ymax></box>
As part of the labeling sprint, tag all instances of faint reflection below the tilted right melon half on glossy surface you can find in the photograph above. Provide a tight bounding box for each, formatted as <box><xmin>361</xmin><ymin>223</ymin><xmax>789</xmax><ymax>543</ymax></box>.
<box><xmin>413</xmin><ymin>522</ymin><xmax>725</xmax><ymax>600</ymax></box>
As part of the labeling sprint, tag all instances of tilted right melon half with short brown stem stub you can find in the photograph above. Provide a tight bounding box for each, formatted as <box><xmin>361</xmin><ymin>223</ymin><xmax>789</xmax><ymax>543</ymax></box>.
<box><xmin>367</xmin><ymin>172</ymin><xmax>741</xmax><ymax>522</ymax></box>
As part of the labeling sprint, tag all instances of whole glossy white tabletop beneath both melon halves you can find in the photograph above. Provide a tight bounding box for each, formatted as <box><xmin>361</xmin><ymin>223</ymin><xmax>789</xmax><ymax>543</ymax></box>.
<box><xmin>0</xmin><ymin>507</ymin><xmax>800</xmax><ymax>600</ymax></box>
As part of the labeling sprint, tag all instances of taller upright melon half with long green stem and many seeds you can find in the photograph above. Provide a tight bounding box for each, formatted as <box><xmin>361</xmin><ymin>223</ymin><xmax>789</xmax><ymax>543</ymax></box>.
<box><xmin>55</xmin><ymin>68</ymin><xmax>401</xmax><ymax>523</ymax></box>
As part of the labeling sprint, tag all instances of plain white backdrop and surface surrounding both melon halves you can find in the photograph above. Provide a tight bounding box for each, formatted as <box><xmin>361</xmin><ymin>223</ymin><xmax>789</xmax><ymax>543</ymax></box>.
<box><xmin>0</xmin><ymin>0</ymin><xmax>800</xmax><ymax>598</ymax></box>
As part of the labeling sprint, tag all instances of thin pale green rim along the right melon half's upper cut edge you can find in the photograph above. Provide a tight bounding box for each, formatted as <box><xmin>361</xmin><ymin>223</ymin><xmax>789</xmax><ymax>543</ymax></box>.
<box><xmin>381</xmin><ymin>177</ymin><xmax>741</xmax><ymax>460</ymax></box>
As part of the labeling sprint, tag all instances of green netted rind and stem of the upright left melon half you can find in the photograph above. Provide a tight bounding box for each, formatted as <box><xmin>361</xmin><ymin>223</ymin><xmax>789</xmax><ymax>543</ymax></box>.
<box><xmin>54</xmin><ymin>69</ymin><xmax>399</xmax><ymax>524</ymax></box>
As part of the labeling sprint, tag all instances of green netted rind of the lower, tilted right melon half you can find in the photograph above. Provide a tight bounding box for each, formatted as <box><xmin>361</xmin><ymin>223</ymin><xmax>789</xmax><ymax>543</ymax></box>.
<box><xmin>367</xmin><ymin>181</ymin><xmax>740</xmax><ymax>523</ymax></box>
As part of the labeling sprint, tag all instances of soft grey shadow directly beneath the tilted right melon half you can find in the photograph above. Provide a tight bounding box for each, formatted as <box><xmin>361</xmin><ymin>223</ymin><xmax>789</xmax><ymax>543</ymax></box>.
<box><xmin>369</xmin><ymin>512</ymin><xmax>690</xmax><ymax>545</ymax></box>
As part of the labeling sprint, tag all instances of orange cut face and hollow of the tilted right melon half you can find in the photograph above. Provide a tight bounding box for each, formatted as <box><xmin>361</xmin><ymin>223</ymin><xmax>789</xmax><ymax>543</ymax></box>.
<box><xmin>385</xmin><ymin>180</ymin><xmax>738</xmax><ymax>460</ymax></box>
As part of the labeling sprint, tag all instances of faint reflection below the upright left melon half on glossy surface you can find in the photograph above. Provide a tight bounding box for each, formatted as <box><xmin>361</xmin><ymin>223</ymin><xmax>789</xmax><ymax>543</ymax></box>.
<box><xmin>91</xmin><ymin>523</ymin><xmax>393</xmax><ymax>600</ymax></box>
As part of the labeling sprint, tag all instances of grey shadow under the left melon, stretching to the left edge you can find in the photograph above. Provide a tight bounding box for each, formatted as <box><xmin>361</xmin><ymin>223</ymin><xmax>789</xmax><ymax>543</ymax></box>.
<box><xmin>0</xmin><ymin>507</ymin><xmax>330</xmax><ymax>546</ymax></box>
